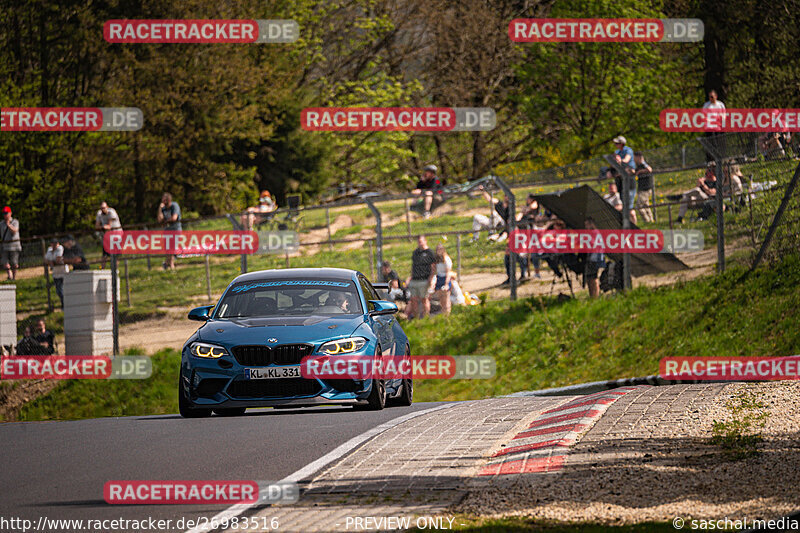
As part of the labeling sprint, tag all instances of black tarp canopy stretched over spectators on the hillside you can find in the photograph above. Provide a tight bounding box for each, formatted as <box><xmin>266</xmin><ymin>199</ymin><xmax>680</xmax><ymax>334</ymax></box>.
<box><xmin>536</xmin><ymin>185</ymin><xmax>689</xmax><ymax>277</ymax></box>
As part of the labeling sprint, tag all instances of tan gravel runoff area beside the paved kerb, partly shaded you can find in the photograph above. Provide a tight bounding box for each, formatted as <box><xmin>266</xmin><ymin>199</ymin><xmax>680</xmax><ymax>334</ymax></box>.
<box><xmin>452</xmin><ymin>382</ymin><xmax>800</xmax><ymax>528</ymax></box>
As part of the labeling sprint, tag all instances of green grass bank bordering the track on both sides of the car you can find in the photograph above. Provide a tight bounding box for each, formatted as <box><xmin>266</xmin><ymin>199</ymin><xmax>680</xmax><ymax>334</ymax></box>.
<box><xmin>10</xmin><ymin>257</ymin><xmax>800</xmax><ymax>420</ymax></box>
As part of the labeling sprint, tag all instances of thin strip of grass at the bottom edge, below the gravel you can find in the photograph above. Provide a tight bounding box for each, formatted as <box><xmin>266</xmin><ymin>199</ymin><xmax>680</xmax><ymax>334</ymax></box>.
<box><xmin>428</xmin><ymin>515</ymin><xmax>676</xmax><ymax>533</ymax></box>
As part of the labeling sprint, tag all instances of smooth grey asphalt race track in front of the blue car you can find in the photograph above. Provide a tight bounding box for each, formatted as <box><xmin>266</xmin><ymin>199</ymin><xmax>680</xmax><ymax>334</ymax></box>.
<box><xmin>0</xmin><ymin>403</ymin><xmax>440</xmax><ymax>524</ymax></box>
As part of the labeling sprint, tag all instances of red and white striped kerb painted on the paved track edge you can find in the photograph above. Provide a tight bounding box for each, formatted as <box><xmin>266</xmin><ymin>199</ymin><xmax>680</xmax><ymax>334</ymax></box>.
<box><xmin>477</xmin><ymin>387</ymin><xmax>639</xmax><ymax>476</ymax></box>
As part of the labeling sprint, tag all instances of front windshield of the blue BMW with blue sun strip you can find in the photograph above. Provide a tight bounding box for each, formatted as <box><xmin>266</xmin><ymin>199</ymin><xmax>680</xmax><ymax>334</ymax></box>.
<box><xmin>215</xmin><ymin>280</ymin><xmax>362</xmax><ymax>318</ymax></box>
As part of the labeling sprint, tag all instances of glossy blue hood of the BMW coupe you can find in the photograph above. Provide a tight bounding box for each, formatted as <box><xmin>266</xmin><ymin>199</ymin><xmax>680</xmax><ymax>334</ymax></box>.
<box><xmin>198</xmin><ymin>315</ymin><xmax>364</xmax><ymax>345</ymax></box>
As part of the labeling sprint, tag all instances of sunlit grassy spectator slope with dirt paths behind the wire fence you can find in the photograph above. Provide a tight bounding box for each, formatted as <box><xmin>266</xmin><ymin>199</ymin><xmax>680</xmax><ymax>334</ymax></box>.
<box><xmin>3</xmin><ymin>134</ymin><xmax>800</xmax><ymax>354</ymax></box>
